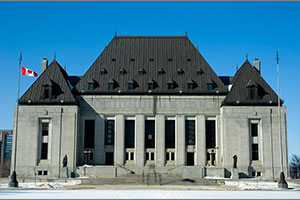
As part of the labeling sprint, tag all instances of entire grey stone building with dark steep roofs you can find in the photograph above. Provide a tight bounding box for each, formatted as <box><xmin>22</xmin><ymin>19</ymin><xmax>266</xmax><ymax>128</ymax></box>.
<box><xmin>12</xmin><ymin>36</ymin><xmax>288</xmax><ymax>178</ymax></box>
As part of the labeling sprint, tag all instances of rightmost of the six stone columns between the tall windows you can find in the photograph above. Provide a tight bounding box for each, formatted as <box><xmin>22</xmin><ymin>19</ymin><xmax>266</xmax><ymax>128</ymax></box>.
<box><xmin>196</xmin><ymin>115</ymin><xmax>206</xmax><ymax>167</ymax></box>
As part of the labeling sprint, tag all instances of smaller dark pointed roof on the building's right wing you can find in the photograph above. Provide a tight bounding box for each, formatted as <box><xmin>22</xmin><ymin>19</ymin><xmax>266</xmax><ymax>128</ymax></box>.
<box><xmin>223</xmin><ymin>60</ymin><xmax>282</xmax><ymax>105</ymax></box>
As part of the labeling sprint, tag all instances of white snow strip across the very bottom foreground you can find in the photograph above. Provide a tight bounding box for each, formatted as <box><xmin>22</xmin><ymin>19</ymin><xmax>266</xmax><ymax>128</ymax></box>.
<box><xmin>0</xmin><ymin>190</ymin><xmax>300</xmax><ymax>199</ymax></box>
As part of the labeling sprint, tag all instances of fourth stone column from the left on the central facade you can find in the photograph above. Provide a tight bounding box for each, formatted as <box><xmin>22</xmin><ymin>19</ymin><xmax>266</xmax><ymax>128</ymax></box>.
<box><xmin>155</xmin><ymin>115</ymin><xmax>166</xmax><ymax>166</ymax></box>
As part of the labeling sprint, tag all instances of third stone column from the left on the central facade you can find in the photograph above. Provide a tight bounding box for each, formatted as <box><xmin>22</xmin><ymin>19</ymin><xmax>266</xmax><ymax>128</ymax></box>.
<box><xmin>135</xmin><ymin>115</ymin><xmax>145</xmax><ymax>166</ymax></box>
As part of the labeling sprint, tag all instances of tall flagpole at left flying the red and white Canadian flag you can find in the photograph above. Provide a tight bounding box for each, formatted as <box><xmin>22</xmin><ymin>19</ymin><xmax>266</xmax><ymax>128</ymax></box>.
<box><xmin>8</xmin><ymin>52</ymin><xmax>22</xmax><ymax>187</ymax></box>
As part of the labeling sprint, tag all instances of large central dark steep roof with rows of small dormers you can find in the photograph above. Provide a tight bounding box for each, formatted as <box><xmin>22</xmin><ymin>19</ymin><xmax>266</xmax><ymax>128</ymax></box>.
<box><xmin>76</xmin><ymin>36</ymin><xmax>228</xmax><ymax>94</ymax></box>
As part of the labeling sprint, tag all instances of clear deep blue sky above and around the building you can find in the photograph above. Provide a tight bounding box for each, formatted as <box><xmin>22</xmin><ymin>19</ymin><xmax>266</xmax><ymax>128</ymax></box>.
<box><xmin>0</xmin><ymin>2</ymin><xmax>300</xmax><ymax>158</ymax></box>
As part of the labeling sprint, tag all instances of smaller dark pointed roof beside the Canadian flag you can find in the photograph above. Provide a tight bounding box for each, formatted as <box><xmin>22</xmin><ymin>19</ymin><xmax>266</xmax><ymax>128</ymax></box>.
<box><xmin>19</xmin><ymin>60</ymin><xmax>77</xmax><ymax>105</ymax></box>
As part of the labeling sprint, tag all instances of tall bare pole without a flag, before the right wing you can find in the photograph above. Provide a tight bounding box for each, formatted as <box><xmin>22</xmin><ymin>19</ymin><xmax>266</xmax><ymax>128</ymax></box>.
<box><xmin>276</xmin><ymin>51</ymin><xmax>288</xmax><ymax>189</ymax></box>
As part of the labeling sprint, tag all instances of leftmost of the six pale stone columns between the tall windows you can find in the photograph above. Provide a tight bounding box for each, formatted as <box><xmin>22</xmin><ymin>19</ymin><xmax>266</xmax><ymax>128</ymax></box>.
<box><xmin>94</xmin><ymin>115</ymin><xmax>104</xmax><ymax>165</ymax></box>
